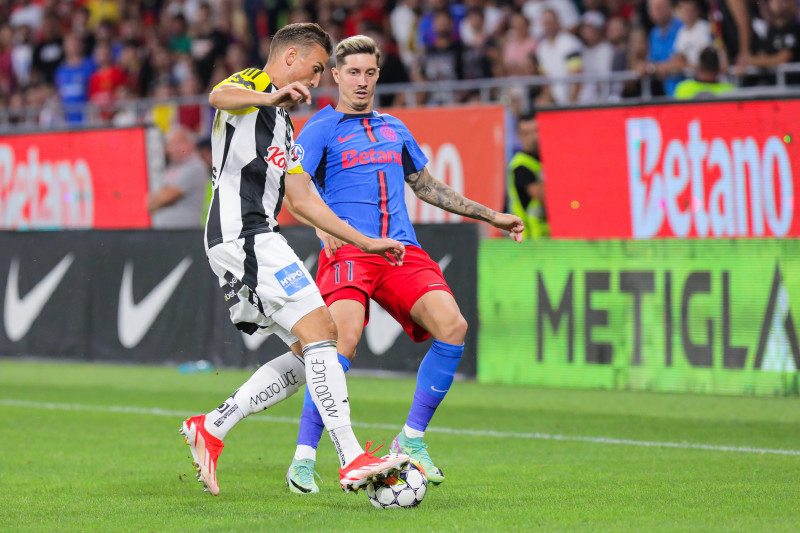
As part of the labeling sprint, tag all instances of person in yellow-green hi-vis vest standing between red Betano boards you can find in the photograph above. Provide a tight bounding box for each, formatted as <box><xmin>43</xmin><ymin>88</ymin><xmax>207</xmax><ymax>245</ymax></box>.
<box><xmin>506</xmin><ymin>114</ymin><xmax>550</xmax><ymax>239</ymax></box>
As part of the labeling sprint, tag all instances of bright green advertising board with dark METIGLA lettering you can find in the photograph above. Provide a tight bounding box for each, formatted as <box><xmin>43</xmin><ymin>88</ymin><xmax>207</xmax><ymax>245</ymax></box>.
<box><xmin>478</xmin><ymin>239</ymin><xmax>800</xmax><ymax>395</ymax></box>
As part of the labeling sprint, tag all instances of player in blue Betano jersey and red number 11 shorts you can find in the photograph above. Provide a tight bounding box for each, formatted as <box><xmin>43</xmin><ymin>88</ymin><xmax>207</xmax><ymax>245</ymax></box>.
<box><xmin>286</xmin><ymin>36</ymin><xmax>524</xmax><ymax>493</ymax></box>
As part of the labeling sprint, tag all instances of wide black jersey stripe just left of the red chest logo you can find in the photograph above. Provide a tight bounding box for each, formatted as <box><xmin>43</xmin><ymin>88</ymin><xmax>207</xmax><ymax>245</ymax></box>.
<box><xmin>239</xmin><ymin>106</ymin><xmax>277</xmax><ymax>238</ymax></box>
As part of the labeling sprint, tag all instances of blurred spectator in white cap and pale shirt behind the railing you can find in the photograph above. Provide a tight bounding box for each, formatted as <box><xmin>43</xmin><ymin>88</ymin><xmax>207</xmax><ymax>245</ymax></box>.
<box><xmin>579</xmin><ymin>11</ymin><xmax>614</xmax><ymax>104</ymax></box>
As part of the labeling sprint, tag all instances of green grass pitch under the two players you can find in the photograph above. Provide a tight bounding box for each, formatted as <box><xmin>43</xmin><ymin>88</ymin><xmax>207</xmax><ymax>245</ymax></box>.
<box><xmin>0</xmin><ymin>360</ymin><xmax>800</xmax><ymax>533</ymax></box>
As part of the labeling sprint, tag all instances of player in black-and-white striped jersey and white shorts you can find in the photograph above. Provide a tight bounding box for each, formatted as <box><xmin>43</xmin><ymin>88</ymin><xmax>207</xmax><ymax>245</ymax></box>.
<box><xmin>181</xmin><ymin>24</ymin><xmax>409</xmax><ymax>495</ymax></box>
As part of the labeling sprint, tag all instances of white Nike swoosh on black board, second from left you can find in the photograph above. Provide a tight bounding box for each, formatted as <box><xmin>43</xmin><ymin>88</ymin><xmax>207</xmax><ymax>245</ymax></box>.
<box><xmin>117</xmin><ymin>257</ymin><xmax>192</xmax><ymax>348</ymax></box>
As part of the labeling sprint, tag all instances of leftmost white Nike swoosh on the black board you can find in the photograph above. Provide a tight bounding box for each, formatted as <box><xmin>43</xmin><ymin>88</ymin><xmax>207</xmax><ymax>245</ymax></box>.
<box><xmin>3</xmin><ymin>254</ymin><xmax>75</xmax><ymax>342</ymax></box>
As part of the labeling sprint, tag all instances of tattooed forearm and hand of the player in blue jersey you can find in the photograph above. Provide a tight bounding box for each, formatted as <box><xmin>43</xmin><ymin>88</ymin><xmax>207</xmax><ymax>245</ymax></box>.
<box><xmin>406</xmin><ymin>167</ymin><xmax>525</xmax><ymax>242</ymax></box>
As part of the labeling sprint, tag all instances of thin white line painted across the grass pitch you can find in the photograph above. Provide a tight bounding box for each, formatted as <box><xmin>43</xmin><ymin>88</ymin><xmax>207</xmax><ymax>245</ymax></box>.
<box><xmin>0</xmin><ymin>399</ymin><xmax>800</xmax><ymax>456</ymax></box>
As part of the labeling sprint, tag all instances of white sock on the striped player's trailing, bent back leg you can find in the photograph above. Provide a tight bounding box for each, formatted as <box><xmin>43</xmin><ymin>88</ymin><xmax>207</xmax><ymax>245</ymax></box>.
<box><xmin>205</xmin><ymin>352</ymin><xmax>306</xmax><ymax>439</ymax></box>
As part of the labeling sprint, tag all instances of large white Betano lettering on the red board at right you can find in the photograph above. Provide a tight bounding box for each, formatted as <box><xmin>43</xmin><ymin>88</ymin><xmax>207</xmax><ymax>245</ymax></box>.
<box><xmin>625</xmin><ymin>117</ymin><xmax>794</xmax><ymax>239</ymax></box>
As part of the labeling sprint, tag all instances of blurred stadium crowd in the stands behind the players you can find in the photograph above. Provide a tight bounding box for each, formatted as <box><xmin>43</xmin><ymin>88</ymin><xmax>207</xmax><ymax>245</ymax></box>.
<box><xmin>0</xmin><ymin>0</ymin><xmax>800</xmax><ymax>129</ymax></box>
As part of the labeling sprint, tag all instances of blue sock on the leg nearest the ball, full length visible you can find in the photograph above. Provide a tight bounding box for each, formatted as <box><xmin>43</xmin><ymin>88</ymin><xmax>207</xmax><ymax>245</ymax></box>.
<box><xmin>406</xmin><ymin>340</ymin><xmax>464</xmax><ymax>431</ymax></box>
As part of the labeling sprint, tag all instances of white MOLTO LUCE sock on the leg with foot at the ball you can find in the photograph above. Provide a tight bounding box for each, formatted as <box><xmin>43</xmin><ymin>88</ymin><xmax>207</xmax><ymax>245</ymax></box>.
<box><xmin>303</xmin><ymin>341</ymin><xmax>364</xmax><ymax>466</ymax></box>
